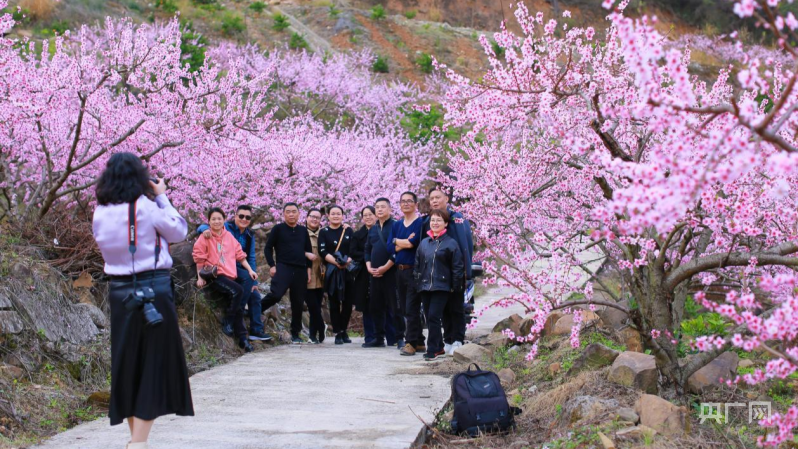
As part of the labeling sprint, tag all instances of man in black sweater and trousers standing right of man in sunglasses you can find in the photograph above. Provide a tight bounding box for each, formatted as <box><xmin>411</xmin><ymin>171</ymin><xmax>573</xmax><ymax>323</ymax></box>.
<box><xmin>262</xmin><ymin>203</ymin><xmax>316</xmax><ymax>345</ymax></box>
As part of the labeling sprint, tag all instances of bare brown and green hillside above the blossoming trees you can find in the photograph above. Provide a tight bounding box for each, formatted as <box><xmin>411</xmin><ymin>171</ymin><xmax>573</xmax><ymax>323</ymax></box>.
<box><xmin>1</xmin><ymin>0</ymin><xmax>720</xmax><ymax>83</ymax></box>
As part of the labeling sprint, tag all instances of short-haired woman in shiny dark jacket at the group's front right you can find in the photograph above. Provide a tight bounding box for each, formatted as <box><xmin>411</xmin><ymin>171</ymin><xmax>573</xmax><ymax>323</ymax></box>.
<box><xmin>413</xmin><ymin>209</ymin><xmax>465</xmax><ymax>360</ymax></box>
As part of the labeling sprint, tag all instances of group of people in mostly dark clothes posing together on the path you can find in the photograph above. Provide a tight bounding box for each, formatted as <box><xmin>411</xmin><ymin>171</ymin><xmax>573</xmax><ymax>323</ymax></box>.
<box><xmin>193</xmin><ymin>187</ymin><xmax>473</xmax><ymax>360</ymax></box>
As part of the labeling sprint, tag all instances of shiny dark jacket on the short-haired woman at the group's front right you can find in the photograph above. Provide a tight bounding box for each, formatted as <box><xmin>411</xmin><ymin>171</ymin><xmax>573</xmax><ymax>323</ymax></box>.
<box><xmin>413</xmin><ymin>233</ymin><xmax>465</xmax><ymax>292</ymax></box>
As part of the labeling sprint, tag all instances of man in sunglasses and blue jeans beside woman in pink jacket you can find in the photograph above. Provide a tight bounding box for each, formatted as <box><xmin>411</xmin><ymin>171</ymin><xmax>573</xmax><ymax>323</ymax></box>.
<box><xmin>197</xmin><ymin>205</ymin><xmax>272</xmax><ymax>341</ymax></box>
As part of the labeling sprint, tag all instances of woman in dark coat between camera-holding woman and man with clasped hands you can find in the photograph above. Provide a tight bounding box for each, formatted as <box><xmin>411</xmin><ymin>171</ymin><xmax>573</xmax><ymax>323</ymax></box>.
<box><xmin>349</xmin><ymin>206</ymin><xmax>377</xmax><ymax>343</ymax></box>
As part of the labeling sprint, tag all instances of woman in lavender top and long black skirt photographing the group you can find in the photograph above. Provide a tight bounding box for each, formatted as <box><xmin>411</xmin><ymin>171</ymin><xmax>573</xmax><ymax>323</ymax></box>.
<box><xmin>92</xmin><ymin>153</ymin><xmax>194</xmax><ymax>449</ymax></box>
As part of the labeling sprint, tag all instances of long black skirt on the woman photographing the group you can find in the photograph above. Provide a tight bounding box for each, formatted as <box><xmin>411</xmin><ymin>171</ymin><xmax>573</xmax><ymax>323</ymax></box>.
<box><xmin>108</xmin><ymin>270</ymin><xmax>194</xmax><ymax>426</ymax></box>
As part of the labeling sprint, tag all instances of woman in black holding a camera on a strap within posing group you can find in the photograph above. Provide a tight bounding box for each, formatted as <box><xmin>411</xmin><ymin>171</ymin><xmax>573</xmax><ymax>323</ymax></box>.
<box><xmin>319</xmin><ymin>205</ymin><xmax>354</xmax><ymax>345</ymax></box>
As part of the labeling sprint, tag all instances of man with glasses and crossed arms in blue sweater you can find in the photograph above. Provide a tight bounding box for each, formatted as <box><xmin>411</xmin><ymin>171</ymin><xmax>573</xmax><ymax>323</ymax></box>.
<box><xmin>389</xmin><ymin>192</ymin><xmax>427</xmax><ymax>356</ymax></box>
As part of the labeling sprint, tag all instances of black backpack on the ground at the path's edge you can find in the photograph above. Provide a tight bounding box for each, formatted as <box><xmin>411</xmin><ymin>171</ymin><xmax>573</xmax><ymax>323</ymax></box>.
<box><xmin>452</xmin><ymin>363</ymin><xmax>520</xmax><ymax>437</ymax></box>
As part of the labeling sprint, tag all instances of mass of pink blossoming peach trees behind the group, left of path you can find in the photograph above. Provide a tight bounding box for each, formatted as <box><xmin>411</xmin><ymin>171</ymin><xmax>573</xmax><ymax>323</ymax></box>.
<box><xmin>0</xmin><ymin>4</ymin><xmax>435</xmax><ymax>221</ymax></box>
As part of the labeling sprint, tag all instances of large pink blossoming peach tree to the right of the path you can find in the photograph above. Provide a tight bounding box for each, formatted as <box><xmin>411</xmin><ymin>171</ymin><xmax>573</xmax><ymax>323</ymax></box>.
<box><xmin>441</xmin><ymin>0</ymin><xmax>798</xmax><ymax>440</ymax></box>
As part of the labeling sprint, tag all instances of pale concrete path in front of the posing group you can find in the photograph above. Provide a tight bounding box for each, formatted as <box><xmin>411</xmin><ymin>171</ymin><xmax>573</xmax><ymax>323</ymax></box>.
<box><xmin>32</xmin><ymin>337</ymin><xmax>450</xmax><ymax>449</ymax></box>
